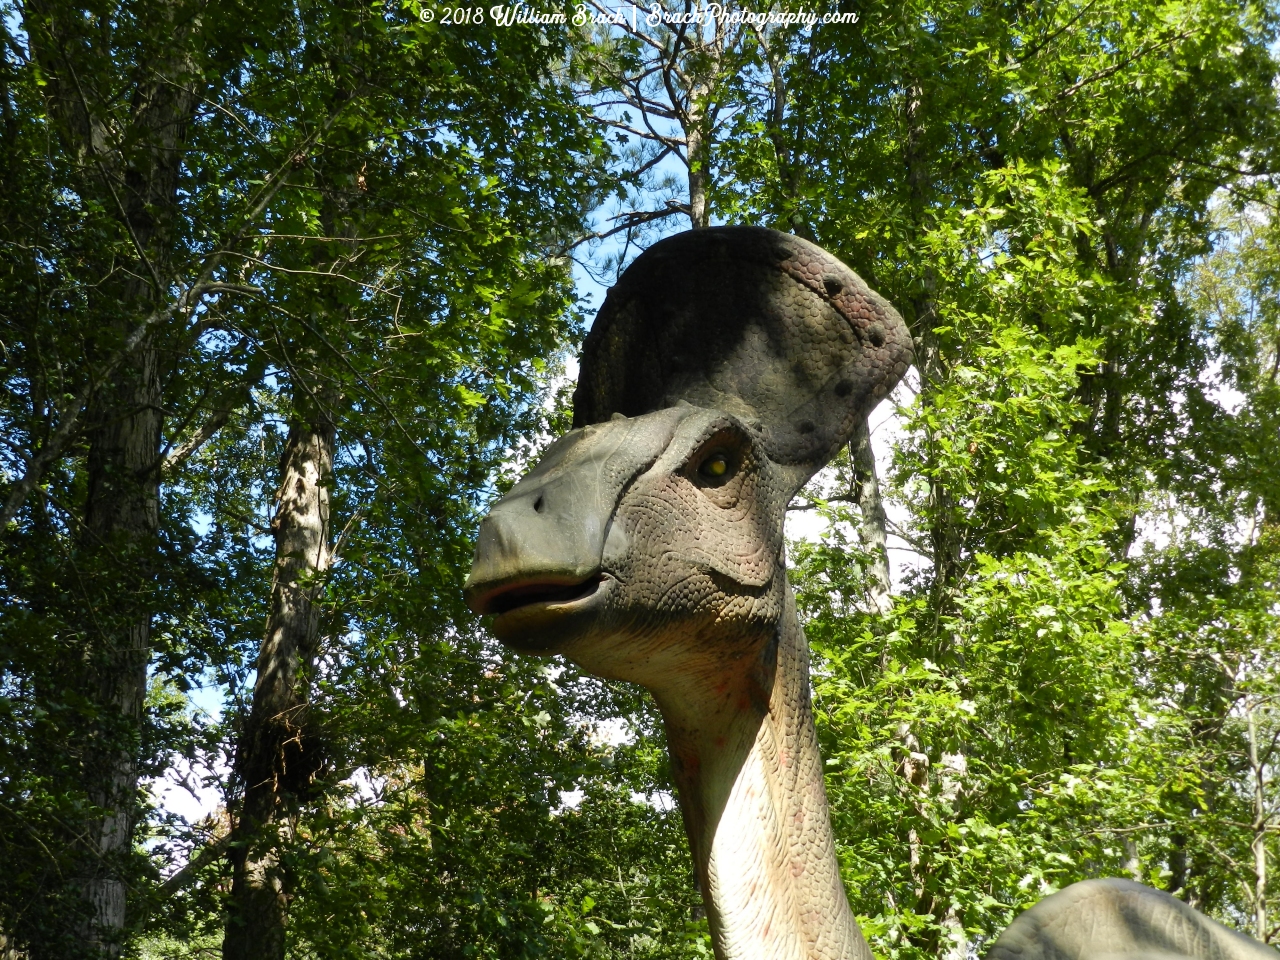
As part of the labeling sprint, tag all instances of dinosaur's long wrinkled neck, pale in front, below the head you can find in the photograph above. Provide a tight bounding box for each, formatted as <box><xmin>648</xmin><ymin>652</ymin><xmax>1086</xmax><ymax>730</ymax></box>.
<box><xmin>657</xmin><ymin>589</ymin><xmax>870</xmax><ymax>960</ymax></box>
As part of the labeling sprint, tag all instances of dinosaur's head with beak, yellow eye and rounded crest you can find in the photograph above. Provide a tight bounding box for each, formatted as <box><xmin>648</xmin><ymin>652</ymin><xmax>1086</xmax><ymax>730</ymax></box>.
<box><xmin>466</xmin><ymin>227</ymin><xmax>911</xmax><ymax>690</ymax></box>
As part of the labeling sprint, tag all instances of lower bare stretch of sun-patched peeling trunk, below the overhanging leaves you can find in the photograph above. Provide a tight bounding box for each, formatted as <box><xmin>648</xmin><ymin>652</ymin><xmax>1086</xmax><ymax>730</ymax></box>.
<box><xmin>223</xmin><ymin>409</ymin><xmax>334</xmax><ymax>960</ymax></box>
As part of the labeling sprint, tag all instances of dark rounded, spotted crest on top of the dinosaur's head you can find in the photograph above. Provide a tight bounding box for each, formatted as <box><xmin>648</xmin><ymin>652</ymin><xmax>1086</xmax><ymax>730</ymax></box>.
<box><xmin>573</xmin><ymin>227</ymin><xmax>911</xmax><ymax>488</ymax></box>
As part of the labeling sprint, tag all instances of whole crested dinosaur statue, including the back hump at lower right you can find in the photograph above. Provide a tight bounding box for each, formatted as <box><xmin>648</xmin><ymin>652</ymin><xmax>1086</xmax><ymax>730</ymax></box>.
<box><xmin>466</xmin><ymin>227</ymin><xmax>1276</xmax><ymax>960</ymax></box>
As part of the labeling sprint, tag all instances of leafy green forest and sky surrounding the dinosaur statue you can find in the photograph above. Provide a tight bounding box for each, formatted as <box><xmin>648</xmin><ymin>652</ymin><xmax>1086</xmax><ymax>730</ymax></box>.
<box><xmin>0</xmin><ymin>0</ymin><xmax>1280</xmax><ymax>960</ymax></box>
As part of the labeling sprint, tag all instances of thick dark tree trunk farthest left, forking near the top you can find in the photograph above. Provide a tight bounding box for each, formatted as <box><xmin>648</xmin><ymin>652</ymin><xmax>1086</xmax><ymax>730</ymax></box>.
<box><xmin>23</xmin><ymin>0</ymin><xmax>202</xmax><ymax>957</ymax></box>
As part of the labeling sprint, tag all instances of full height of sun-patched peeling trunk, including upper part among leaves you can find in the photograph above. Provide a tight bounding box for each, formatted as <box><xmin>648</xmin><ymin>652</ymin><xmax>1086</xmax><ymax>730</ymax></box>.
<box><xmin>223</xmin><ymin>39</ymin><xmax>362</xmax><ymax>960</ymax></box>
